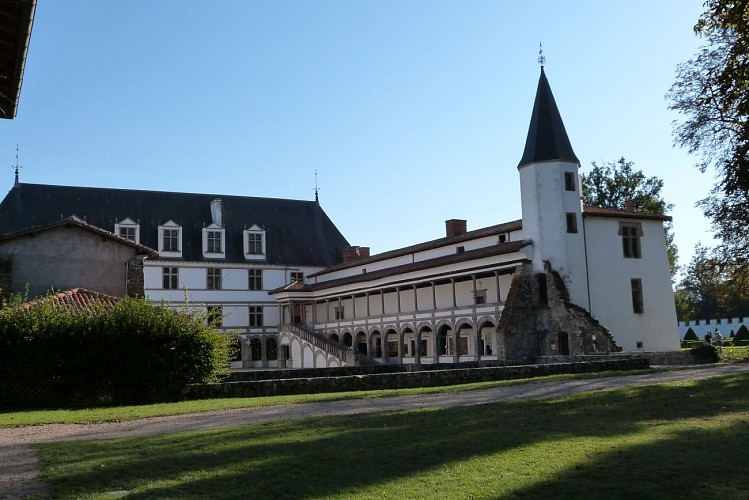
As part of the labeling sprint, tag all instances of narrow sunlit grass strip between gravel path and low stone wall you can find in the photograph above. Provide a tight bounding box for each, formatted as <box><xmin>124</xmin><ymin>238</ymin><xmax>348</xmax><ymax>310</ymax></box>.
<box><xmin>0</xmin><ymin>370</ymin><xmax>642</xmax><ymax>428</ymax></box>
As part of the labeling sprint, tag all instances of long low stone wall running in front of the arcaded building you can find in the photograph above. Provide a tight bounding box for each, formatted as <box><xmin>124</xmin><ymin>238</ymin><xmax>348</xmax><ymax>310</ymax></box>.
<box><xmin>183</xmin><ymin>358</ymin><xmax>649</xmax><ymax>399</ymax></box>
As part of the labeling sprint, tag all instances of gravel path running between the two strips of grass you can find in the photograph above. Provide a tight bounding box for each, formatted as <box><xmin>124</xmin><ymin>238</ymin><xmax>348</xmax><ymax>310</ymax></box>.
<box><xmin>0</xmin><ymin>364</ymin><xmax>749</xmax><ymax>499</ymax></box>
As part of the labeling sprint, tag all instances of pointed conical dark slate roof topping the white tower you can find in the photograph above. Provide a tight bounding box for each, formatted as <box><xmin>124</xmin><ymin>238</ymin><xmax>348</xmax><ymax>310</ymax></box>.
<box><xmin>518</xmin><ymin>66</ymin><xmax>580</xmax><ymax>167</ymax></box>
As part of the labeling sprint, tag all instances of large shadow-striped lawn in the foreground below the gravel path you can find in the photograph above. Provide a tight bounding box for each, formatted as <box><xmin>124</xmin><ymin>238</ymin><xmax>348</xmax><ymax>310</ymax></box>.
<box><xmin>35</xmin><ymin>374</ymin><xmax>749</xmax><ymax>499</ymax></box>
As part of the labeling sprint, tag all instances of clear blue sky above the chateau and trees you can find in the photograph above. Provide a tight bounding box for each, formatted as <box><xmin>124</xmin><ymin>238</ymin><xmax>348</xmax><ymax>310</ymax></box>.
<box><xmin>0</xmin><ymin>0</ymin><xmax>713</xmax><ymax>274</ymax></box>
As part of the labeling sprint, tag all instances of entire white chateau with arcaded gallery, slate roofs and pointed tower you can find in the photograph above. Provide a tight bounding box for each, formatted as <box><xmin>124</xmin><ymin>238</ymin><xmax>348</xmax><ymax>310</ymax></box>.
<box><xmin>0</xmin><ymin>67</ymin><xmax>679</xmax><ymax>368</ymax></box>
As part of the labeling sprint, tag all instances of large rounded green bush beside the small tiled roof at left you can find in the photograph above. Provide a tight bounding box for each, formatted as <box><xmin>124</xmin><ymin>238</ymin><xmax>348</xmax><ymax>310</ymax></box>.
<box><xmin>0</xmin><ymin>298</ymin><xmax>232</xmax><ymax>408</ymax></box>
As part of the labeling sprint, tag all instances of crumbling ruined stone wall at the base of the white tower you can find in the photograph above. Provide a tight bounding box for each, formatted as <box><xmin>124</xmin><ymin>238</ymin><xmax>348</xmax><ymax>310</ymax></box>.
<box><xmin>497</xmin><ymin>264</ymin><xmax>621</xmax><ymax>362</ymax></box>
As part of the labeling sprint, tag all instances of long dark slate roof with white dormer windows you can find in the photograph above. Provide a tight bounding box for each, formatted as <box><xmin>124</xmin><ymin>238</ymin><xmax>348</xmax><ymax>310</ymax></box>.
<box><xmin>0</xmin><ymin>183</ymin><xmax>348</xmax><ymax>266</ymax></box>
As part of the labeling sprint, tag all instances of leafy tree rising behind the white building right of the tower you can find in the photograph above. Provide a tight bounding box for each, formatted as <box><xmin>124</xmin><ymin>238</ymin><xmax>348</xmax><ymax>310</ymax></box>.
<box><xmin>582</xmin><ymin>157</ymin><xmax>678</xmax><ymax>277</ymax></box>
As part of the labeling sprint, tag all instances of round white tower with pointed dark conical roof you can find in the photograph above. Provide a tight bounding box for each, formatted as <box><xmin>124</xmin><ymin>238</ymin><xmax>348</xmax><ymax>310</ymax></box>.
<box><xmin>518</xmin><ymin>66</ymin><xmax>590</xmax><ymax>309</ymax></box>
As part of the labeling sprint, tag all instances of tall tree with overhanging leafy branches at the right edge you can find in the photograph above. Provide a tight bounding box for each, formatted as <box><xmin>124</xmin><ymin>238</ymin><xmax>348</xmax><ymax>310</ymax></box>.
<box><xmin>666</xmin><ymin>0</ymin><xmax>749</xmax><ymax>265</ymax></box>
